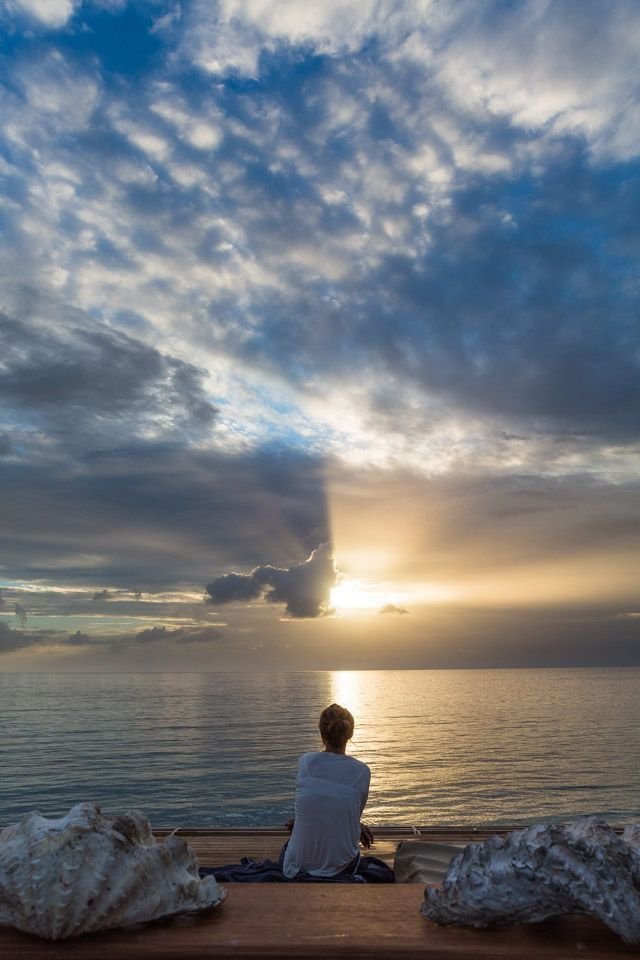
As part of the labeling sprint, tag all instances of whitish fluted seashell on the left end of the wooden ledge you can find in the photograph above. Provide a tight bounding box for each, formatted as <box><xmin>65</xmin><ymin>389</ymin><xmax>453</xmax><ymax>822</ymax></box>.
<box><xmin>0</xmin><ymin>803</ymin><xmax>226</xmax><ymax>940</ymax></box>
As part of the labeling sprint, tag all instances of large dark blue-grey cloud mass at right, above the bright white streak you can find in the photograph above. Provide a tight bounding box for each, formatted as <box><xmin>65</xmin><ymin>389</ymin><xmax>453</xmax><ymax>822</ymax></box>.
<box><xmin>218</xmin><ymin>131</ymin><xmax>640</xmax><ymax>452</ymax></box>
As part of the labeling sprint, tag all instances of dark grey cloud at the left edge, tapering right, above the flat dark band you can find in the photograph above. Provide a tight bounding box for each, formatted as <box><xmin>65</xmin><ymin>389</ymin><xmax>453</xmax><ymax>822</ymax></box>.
<box><xmin>0</xmin><ymin>291</ymin><xmax>215</xmax><ymax>458</ymax></box>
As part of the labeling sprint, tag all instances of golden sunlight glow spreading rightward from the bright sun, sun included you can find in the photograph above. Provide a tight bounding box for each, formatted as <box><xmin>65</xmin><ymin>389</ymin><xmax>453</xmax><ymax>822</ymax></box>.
<box><xmin>327</xmin><ymin>471</ymin><xmax>637</xmax><ymax>619</ymax></box>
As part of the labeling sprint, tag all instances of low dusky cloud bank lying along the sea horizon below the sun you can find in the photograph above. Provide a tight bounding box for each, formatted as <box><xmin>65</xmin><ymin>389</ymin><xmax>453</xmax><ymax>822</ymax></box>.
<box><xmin>0</xmin><ymin>605</ymin><xmax>640</xmax><ymax>670</ymax></box>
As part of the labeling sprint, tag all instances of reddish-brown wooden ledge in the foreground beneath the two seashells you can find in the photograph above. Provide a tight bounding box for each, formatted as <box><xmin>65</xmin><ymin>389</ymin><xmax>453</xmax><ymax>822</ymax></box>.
<box><xmin>0</xmin><ymin>883</ymin><xmax>638</xmax><ymax>960</ymax></box>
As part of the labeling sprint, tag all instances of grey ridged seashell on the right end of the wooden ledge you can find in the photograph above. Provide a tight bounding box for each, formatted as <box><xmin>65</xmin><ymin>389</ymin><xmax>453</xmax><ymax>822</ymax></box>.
<box><xmin>422</xmin><ymin>817</ymin><xmax>640</xmax><ymax>943</ymax></box>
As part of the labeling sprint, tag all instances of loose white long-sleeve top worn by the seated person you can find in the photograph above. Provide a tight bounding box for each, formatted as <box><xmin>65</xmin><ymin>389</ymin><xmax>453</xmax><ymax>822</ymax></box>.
<box><xmin>283</xmin><ymin>752</ymin><xmax>371</xmax><ymax>878</ymax></box>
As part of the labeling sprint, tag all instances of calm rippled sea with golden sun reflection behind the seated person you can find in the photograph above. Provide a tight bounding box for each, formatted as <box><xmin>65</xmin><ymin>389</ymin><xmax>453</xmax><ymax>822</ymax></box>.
<box><xmin>0</xmin><ymin>669</ymin><xmax>640</xmax><ymax>826</ymax></box>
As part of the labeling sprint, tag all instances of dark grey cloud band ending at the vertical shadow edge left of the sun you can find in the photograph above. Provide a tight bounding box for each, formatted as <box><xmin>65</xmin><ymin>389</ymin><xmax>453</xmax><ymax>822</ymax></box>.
<box><xmin>0</xmin><ymin>446</ymin><xmax>328</xmax><ymax>588</ymax></box>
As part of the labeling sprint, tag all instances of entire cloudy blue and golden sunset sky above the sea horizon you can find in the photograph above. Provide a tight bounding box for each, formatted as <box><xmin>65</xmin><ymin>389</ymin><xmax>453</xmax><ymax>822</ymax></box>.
<box><xmin>0</xmin><ymin>0</ymin><xmax>640</xmax><ymax>672</ymax></box>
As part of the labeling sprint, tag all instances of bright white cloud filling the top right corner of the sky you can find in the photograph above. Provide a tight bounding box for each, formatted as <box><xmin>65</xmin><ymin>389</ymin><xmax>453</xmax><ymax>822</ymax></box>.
<box><xmin>437</xmin><ymin>0</ymin><xmax>640</xmax><ymax>159</ymax></box>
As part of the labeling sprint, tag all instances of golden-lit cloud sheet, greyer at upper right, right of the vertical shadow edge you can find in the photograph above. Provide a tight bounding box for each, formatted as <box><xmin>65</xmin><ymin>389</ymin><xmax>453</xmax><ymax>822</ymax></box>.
<box><xmin>330</xmin><ymin>468</ymin><xmax>640</xmax><ymax>612</ymax></box>
